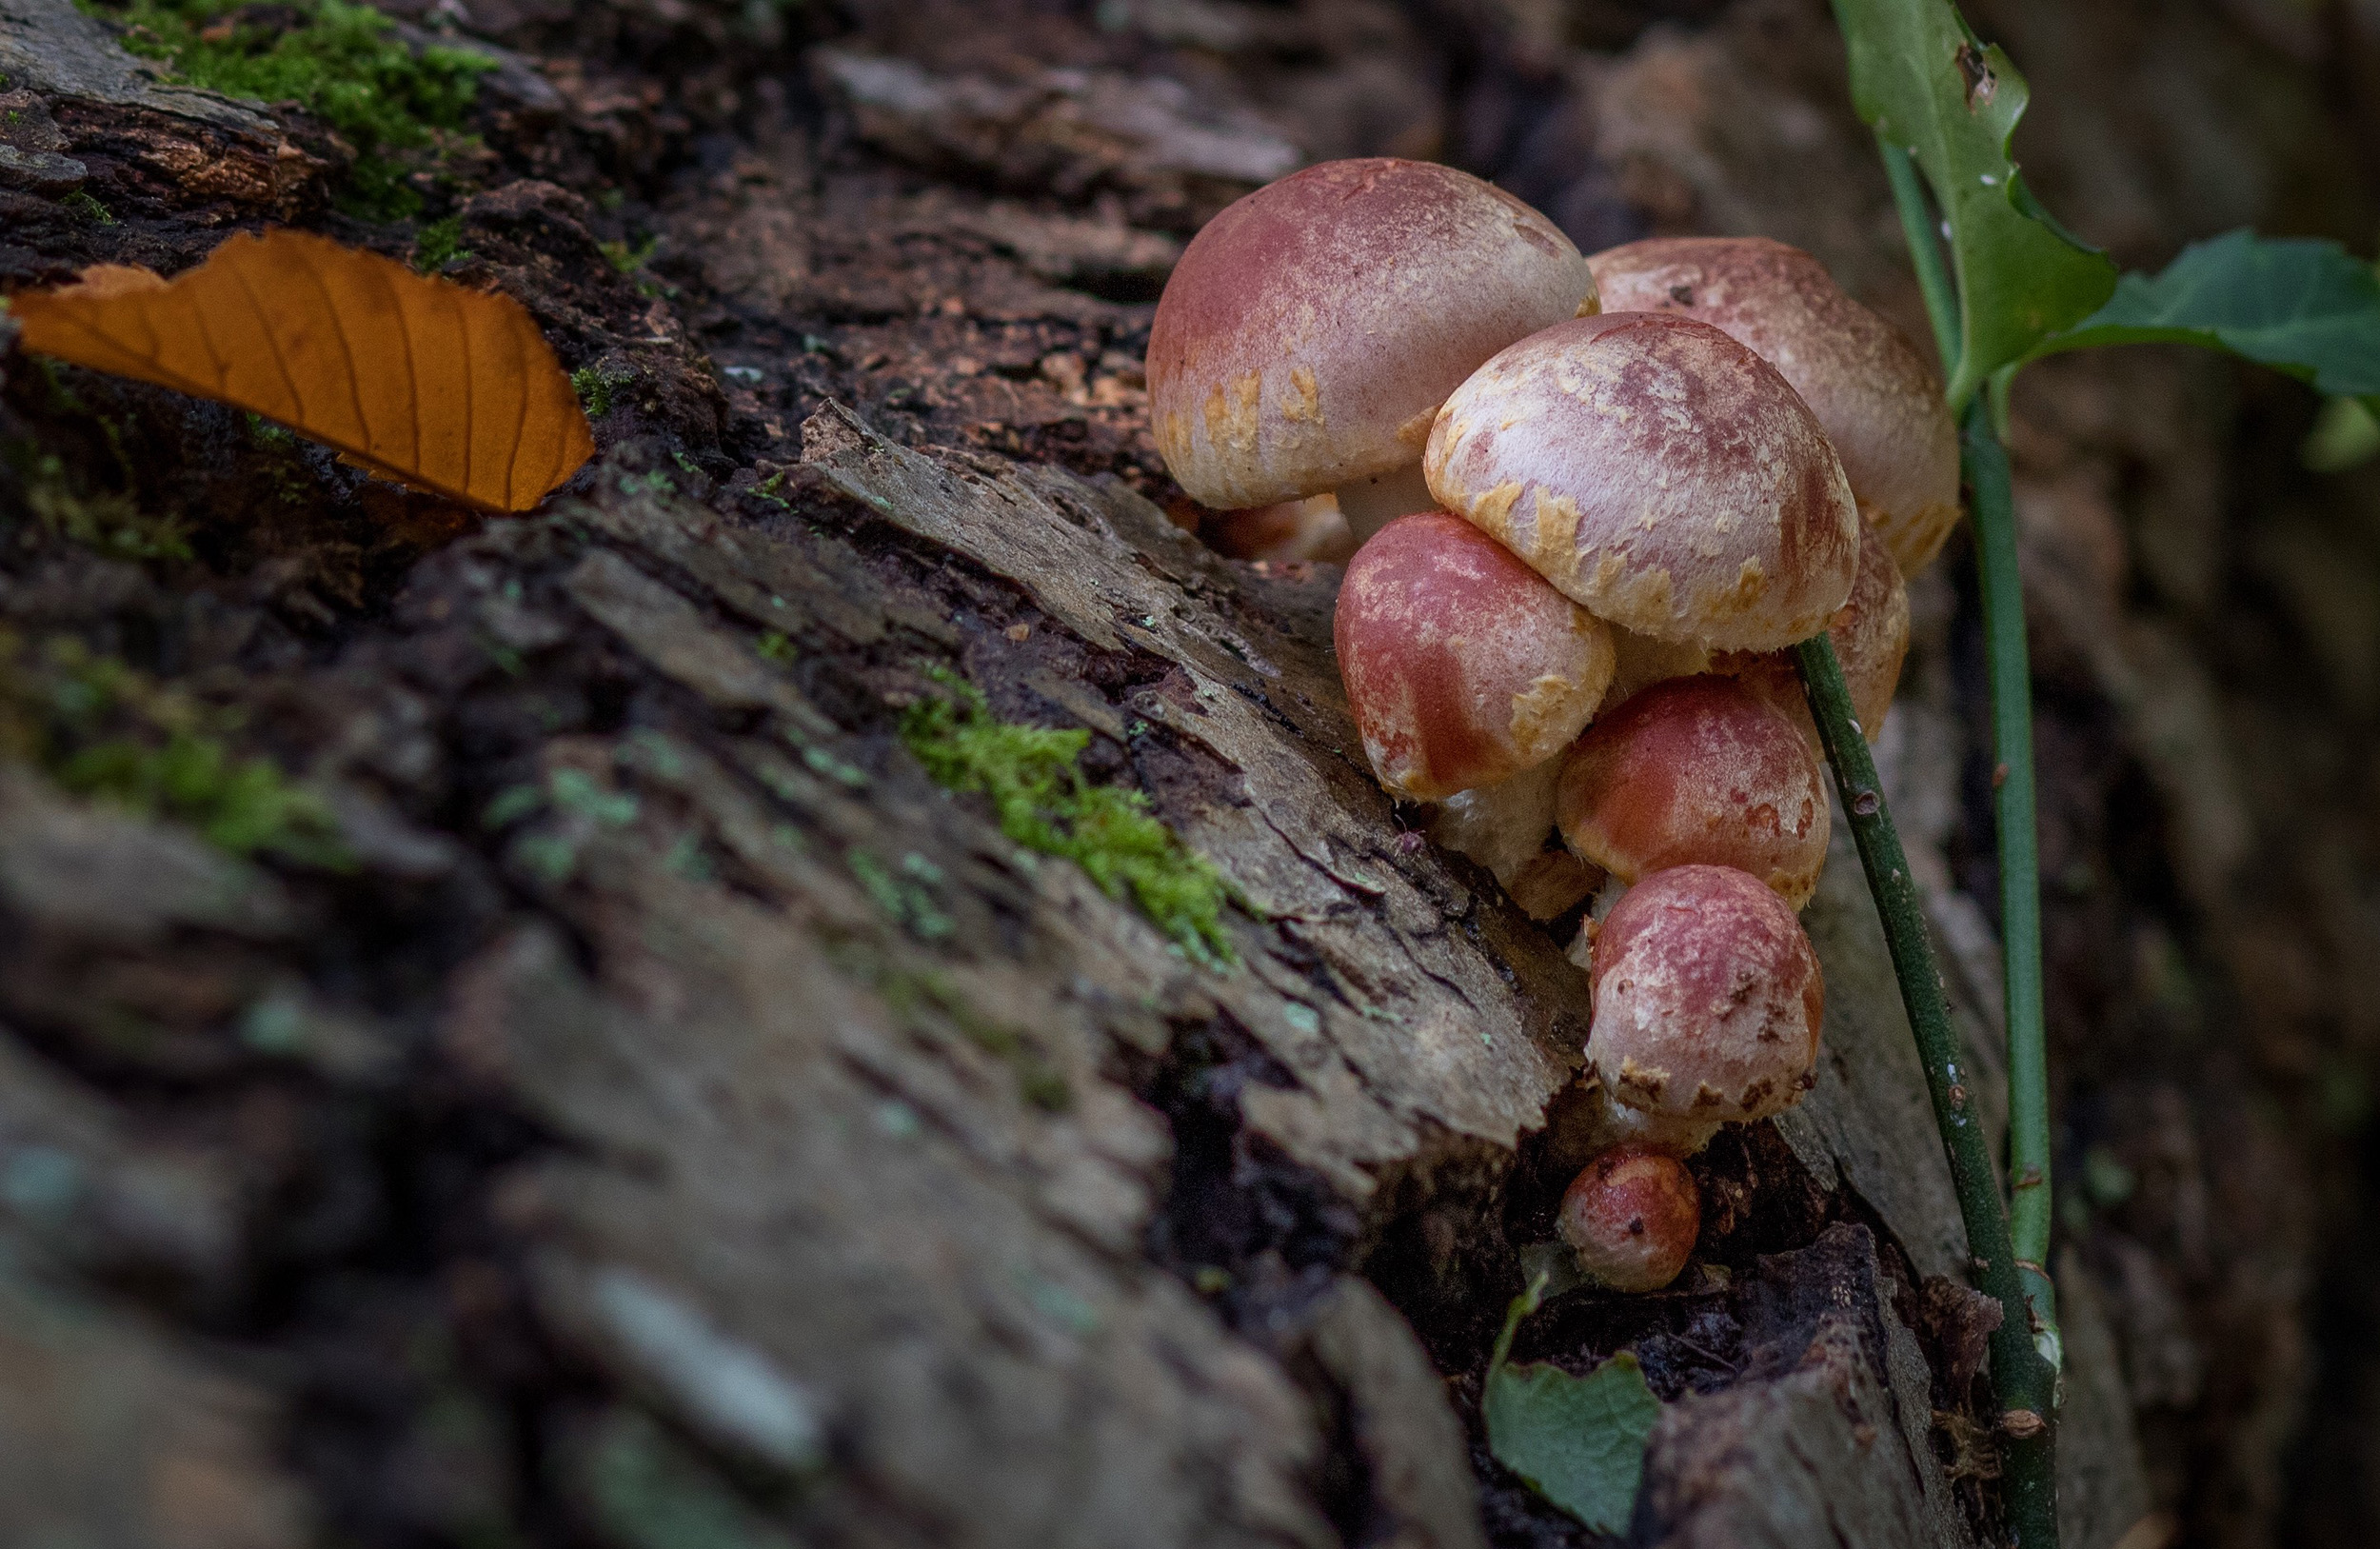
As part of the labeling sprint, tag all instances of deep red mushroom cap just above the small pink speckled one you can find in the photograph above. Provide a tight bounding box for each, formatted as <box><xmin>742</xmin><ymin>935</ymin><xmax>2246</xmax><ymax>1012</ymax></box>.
<box><xmin>1557</xmin><ymin>676</ymin><xmax>1831</xmax><ymax>908</ymax></box>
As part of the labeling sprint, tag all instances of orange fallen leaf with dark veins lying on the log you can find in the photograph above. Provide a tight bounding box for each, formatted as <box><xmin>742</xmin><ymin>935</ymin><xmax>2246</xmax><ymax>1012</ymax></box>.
<box><xmin>10</xmin><ymin>228</ymin><xmax>595</xmax><ymax>511</ymax></box>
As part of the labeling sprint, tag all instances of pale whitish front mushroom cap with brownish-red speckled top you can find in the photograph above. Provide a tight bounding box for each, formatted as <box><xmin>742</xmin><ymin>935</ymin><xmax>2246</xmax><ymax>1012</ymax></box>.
<box><xmin>1421</xmin><ymin>311</ymin><xmax>1859</xmax><ymax>649</ymax></box>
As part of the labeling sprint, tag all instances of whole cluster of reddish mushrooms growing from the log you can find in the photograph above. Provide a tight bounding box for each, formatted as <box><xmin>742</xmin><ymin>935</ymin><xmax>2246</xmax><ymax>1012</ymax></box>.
<box><xmin>1147</xmin><ymin>157</ymin><xmax>1959</xmax><ymax>1290</ymax></box>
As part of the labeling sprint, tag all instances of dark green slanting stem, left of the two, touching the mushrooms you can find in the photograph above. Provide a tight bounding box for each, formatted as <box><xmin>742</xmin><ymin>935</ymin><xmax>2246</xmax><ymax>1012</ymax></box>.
<box><xmin>1795</xmin><ymin>633</ymin><xmax>2059</xmax><ymax>1549</ymax></box>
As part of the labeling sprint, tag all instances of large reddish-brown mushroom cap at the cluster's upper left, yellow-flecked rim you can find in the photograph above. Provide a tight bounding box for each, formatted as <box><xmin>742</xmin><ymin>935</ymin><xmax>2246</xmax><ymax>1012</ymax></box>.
<box><xmin>1147</xmin><ymin>157</ymin><xmax>1595</xmax><ymax>509</ymax></box>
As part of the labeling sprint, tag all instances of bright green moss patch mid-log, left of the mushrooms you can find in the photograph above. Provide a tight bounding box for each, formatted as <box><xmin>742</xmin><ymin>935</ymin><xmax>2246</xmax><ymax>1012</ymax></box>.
<box><xmin>900</xmin><ymin>673</ymin><xmax>1233</xmax><ymax>963</ymax></box>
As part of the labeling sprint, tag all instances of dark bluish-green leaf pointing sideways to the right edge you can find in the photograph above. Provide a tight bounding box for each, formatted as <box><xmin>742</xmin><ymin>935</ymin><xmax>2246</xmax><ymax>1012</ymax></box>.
<box><xmin>2033</xmin><ymin>230</ymin><xmax>2380</xmax><ymax>397</ymax></box>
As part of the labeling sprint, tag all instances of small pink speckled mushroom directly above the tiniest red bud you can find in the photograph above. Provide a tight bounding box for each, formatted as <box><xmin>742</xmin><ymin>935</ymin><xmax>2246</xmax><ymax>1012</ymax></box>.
<box><xmin>1588</xmin><ymin>866</ymin><xmax>1826</xmax><ymax>1123</ymax></box>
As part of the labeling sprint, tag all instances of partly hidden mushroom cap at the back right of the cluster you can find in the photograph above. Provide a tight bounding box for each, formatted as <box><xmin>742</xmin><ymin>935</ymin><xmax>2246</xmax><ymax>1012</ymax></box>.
<box><xmin>1588</xmin><ymin>235</ymin><xmax>1959</xmax><ymax>573</ymax></box>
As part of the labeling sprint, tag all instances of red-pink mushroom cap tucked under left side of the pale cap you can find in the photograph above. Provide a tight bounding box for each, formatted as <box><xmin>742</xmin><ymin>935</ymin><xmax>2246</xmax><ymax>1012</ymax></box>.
<box><xmin>1333</xmin><ymin>511</ymin><xmax>1612</xmax><ymax>802</ymax></box>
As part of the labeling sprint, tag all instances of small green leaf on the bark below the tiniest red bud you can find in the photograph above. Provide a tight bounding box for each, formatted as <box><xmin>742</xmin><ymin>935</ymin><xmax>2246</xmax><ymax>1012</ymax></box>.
<box><xmin>1480</xmin><ymin>1276</ymin><xmax>1661</xmax><ymax>1533</ymax></box>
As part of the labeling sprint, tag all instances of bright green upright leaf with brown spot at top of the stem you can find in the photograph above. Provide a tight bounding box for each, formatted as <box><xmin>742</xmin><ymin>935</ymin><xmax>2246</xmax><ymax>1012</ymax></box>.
<box><xmin>1835</xmin><ymin>0</ymin><xmax>2116</xmax><ymax>409</ymax></box>
